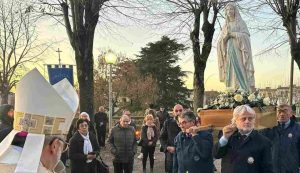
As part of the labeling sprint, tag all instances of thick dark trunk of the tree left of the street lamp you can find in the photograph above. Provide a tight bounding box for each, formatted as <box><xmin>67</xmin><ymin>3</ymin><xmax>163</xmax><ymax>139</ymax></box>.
<box><xmin>60</xmin><ymin>0</ymin><xmax>101</xmax><ymax>121</ymax></box>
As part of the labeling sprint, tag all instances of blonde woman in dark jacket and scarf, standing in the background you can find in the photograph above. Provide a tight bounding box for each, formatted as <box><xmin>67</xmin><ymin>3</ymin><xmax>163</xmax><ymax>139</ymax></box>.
<box><xmin>141</xmin><ymin>114</ymin><xmax>158</xmax><ymax>173</ymax></box>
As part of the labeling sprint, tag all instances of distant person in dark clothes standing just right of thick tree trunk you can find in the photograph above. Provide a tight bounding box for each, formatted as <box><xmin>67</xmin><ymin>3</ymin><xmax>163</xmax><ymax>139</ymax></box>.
<box><xmin>94</xmin><ymin>106</ymin><xmax>108</xmax><ymax>147</ymax></box>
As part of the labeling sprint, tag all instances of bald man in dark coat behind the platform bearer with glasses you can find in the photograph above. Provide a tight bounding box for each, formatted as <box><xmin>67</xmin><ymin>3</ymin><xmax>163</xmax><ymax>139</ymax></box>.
<box><xmin>159</xmin><ymin>104</ymin><xmax>183</xmax><ymax>173</ymax></box>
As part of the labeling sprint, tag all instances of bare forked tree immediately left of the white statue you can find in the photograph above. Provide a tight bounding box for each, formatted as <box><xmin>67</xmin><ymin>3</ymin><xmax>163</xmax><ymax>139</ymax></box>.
<box><xmin>154</xmin><ymin>0</ymin><xmax>236</xmax><ymax>110</ymax></box>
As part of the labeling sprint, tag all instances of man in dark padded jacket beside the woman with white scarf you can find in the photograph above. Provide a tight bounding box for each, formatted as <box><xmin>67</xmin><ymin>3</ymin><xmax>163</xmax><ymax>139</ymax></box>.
<box><xmin>108</xmin><ymin>115</ymin><xmax>137</xmax><ymax>173</ymax></box>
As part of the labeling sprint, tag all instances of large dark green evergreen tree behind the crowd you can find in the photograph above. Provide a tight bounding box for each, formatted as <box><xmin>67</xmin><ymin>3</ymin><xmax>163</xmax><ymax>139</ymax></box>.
<box><xmin>136</xmin><ymin>36</ymin><xmax>189</xmax><ymax>108</ymax></box>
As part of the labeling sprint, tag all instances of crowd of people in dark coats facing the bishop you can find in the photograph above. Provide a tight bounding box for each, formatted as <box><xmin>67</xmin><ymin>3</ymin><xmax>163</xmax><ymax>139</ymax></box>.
<box><xmin>0</xmin><ymin>101</ymin><xmax>300</xmax><ymax>173</ymax></box>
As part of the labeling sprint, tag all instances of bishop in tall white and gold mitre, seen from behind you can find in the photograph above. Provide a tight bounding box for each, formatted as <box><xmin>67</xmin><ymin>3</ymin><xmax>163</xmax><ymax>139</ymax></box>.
<box><xmin>0</xmin><ymin>69</ymin><xmax>79</xmax><ymax>173</ymax></box>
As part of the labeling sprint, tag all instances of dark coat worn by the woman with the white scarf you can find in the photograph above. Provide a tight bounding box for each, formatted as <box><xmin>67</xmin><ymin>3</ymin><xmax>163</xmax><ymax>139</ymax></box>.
<box><xmin>69</xmin><ymin>131</ymin><xmax>100</xmax><ymax>173</ymax></box>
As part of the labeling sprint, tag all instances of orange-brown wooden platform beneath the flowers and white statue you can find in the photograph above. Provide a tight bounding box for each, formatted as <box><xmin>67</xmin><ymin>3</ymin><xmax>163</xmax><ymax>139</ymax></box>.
<box><xmin>200</xmin><ymin>106</ymin><xmax>277</xmax><ymax>130</ymax></box>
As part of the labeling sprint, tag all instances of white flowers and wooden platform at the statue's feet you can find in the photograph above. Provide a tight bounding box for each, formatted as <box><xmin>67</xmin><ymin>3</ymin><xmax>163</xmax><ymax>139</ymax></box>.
<box><xmin>200</xmin><ymin>90</ymin><xmax>277</xmax><ymax>129</ymax></box>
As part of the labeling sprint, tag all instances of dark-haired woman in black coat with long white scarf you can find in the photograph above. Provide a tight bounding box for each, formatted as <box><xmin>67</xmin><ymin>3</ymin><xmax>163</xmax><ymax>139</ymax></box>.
<box><xmin>69</xmin><ymin>119</ymin><xmax>100</xmax><ymax>173</ymax></box>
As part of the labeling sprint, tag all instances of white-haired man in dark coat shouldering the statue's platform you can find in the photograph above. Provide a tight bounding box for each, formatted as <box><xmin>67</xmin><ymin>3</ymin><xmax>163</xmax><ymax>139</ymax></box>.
<box><xmin>213</xmin><ymin>105</ymin><xmax>273</xmax><ymax>173</ymax></box>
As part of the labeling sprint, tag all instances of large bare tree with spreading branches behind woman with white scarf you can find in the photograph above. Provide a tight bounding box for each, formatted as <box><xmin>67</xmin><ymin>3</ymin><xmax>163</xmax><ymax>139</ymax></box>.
<box><xmin>32</xmin><ymin>0</ymin><xmax>146</xmax><ymax>119</ymax></box>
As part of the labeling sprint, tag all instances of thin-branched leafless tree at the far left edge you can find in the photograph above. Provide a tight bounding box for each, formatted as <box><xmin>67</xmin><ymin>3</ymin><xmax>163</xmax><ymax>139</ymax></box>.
<box><xmin>0</xmin><ymin>0</ymin><xmax>47</xmax><ymax>104</ymax></box>
